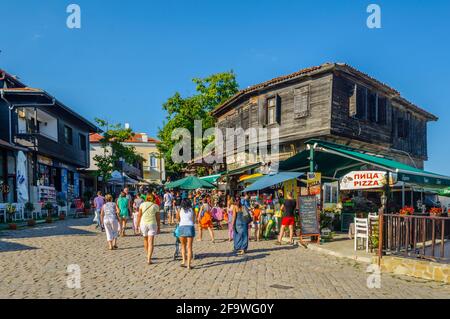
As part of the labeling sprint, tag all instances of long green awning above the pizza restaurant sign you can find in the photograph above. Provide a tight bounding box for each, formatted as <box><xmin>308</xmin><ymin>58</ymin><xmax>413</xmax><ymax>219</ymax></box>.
<box><xmin>280</xmin><ymin>140</ymin><xmax>450</xmax><ymax>188</ymax></box>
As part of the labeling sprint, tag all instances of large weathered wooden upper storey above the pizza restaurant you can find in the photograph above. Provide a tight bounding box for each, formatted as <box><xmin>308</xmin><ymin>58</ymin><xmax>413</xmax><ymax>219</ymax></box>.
<box><xmin>212</xmin><ymin>63</ymin><xmax>437</xmax><ymax>169</ymax></box>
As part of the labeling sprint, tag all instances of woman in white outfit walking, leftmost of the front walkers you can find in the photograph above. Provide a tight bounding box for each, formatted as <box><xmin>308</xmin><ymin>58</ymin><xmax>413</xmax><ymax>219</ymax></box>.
<box><xmin>100</xmin><ymin>194</ymin><xmax>119</xmax><ymax>250</ymax></box>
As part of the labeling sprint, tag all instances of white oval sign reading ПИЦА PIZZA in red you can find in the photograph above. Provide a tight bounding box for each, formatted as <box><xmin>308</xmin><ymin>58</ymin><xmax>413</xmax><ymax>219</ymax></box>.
<box><xmin>340</xmin><ymin>171</ymin><xmax>396</xmax><ymax>190</ymax></box>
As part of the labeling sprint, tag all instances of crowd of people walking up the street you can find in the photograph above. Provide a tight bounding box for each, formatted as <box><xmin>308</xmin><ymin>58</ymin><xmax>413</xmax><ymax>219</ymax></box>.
<box><xmin>93</xmin><ymin>188</ymin><xmax>297</xmax><ymax>269</ymax></box>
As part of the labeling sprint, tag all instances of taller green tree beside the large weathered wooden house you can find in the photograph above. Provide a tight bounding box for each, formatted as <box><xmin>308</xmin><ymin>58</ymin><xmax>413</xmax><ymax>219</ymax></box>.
<box><xmin>158</xmin><ymin>71</ymin><xmax>239</xmax><ymax>179</ymax></box>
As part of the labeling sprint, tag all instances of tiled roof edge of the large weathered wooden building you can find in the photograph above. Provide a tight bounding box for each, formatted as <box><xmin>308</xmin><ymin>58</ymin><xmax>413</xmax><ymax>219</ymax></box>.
<box><xmin>212</xmin><ymin>63</ymin><xmax>437</xmax><ymax>120</ymax></box>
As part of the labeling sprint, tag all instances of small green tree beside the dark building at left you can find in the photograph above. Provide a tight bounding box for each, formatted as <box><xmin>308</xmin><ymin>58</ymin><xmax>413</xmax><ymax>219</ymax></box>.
<box><xmin>93</xmin><ymin>118</ymin><xmax>145</xmax><ymax>190</ymax></box>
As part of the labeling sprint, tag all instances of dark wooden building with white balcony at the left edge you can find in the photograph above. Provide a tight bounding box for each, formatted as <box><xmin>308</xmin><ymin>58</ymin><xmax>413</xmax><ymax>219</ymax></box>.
<box><xmin>0</xmin><ymin>70</ymin><xmax>99</xmax><ymax>203</ymax></box>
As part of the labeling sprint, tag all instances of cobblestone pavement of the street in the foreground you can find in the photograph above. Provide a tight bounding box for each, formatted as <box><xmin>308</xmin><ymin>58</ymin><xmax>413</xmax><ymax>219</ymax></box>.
<box><xmin>0</xmin><ymin>218</ymin><xmax>450</xmax><ymax>298</ymax></box>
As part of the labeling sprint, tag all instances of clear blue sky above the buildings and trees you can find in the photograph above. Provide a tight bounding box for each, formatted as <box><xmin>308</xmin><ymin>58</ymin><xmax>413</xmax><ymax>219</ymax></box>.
<box><xmin>0</xmin><ymin>0</ymin><xmax>450</xmax><ymax>175</ymax></box>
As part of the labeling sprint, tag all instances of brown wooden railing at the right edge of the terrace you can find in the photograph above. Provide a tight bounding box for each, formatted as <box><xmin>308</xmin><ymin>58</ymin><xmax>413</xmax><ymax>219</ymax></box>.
<box><xmin>381</xmin><ymin>214</ymin><xmax>450</xmax><ymax>262</ymax></box>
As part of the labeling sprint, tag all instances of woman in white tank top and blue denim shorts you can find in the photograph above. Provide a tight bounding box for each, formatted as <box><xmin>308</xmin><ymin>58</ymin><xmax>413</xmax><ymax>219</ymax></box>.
<box><xmin>177</xmin><ymin>199</ymin><xmax>195</xmax><ymax>269</ymax></box>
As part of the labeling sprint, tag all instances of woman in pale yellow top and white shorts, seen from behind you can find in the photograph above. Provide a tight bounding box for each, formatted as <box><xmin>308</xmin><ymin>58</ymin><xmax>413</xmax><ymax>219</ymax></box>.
<box><xmin>138</xmin><ymin>194</ymin><xmax>161</xmax><ymax>265</ymax></box>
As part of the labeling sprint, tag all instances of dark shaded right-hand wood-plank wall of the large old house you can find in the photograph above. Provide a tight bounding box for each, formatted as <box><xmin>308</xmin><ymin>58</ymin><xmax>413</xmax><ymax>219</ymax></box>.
<box><xmin>331</xmin><ymin>74</ymin><xmax>427</xmax><ymax>167</ymax></box>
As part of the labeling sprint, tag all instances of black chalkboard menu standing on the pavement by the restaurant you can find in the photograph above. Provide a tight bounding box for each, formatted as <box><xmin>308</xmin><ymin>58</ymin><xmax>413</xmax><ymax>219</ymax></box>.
<box><xmin>298</xmin><ymin>196</ymin><xmax>320</xmax><ymax>236</ymax></box>
